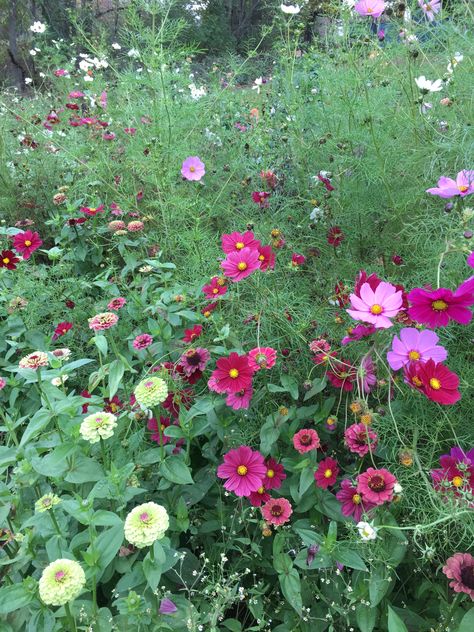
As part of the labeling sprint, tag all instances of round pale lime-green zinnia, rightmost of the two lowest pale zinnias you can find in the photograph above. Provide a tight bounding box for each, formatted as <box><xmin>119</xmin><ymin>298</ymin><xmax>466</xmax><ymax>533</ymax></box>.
<box><xmin>124</xmin><ymin>502</ymin><xmax>170</xmax><ymax>549</ymax></box>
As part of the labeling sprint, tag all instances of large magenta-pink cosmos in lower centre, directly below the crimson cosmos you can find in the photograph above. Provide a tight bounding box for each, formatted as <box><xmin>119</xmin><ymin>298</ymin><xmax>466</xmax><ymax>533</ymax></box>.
<box><xmin>217</xmin><ymin>445</ymin><xmax>267</xmax><ymax>496</ymax></box>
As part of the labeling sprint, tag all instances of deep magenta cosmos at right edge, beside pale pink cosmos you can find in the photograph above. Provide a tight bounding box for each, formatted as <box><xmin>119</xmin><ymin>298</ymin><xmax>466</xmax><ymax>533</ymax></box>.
<box><xmin>408</xmin><ymin>284</ymin><xmax>474</xmax><ymax>328</ymax></box>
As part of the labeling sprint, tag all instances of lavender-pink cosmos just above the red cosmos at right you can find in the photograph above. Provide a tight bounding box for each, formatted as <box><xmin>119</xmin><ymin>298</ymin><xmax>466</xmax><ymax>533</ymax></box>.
<box><xmin>387</xmin><ymin>327</ymin><xmax>448</xmax><ymax>371</ymax></box>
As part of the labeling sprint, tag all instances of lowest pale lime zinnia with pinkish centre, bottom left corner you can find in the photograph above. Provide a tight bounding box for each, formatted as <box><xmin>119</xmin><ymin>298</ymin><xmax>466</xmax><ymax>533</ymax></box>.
<box><xmin>39</xmin><ymin>559</ymin><xmax>86</xmax><ymax>606</ymax></box>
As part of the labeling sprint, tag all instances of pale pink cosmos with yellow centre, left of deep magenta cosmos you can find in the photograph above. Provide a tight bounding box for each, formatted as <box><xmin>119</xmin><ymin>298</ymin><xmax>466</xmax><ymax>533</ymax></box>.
<box><xmin>346</xmin><ymin>281</ymin><xmax>403</xmax><ymax>329</ymax></box>
